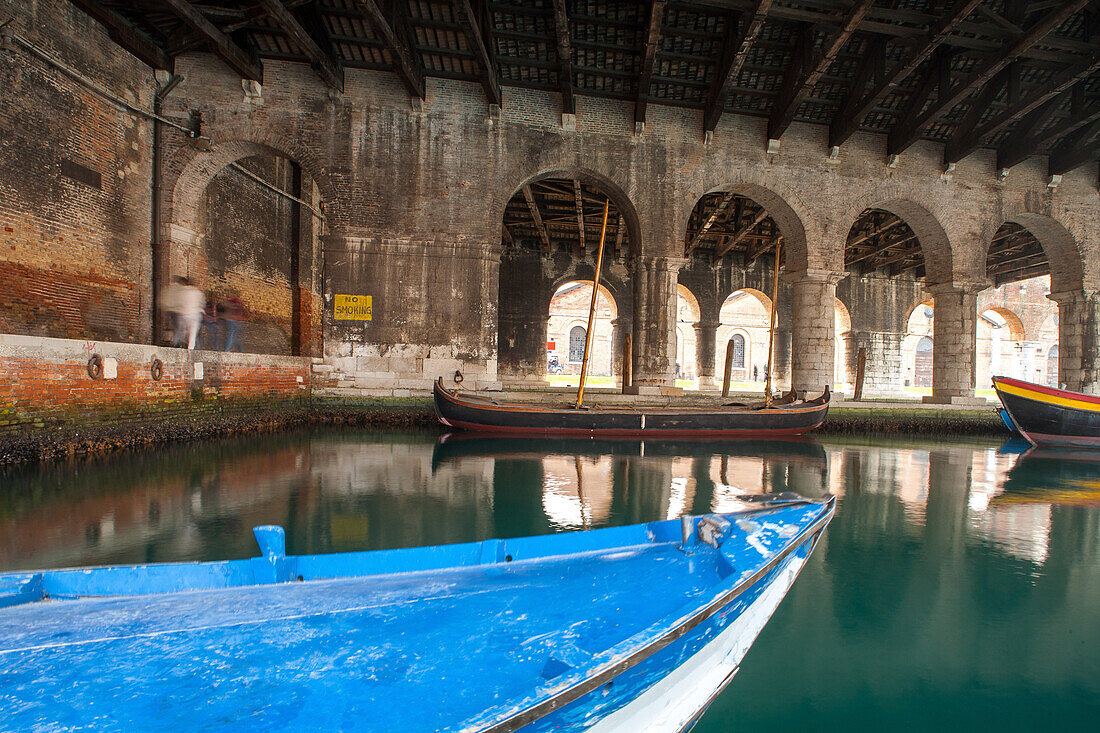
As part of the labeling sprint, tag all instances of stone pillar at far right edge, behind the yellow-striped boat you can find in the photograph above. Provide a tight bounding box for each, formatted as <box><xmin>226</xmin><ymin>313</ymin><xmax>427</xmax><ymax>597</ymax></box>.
<box><xmin>1047</xmin><ymin>289</ymin><xmax>1100</xmax><ymax>394</ymax></box>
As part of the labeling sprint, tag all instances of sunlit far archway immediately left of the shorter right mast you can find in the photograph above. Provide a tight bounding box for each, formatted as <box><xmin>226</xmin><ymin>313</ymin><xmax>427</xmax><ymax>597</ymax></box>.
<box><xmin>714</xmin><ymin>287</ymin><xmax>771</xmax><ymax>391</ymax></box>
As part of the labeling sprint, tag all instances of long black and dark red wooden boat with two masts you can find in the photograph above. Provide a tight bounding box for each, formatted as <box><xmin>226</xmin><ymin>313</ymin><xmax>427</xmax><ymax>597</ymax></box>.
<box><xmin>435</xmin><ymin>378</ymin><xmax>829</xmax><ymax>438</ymax></box>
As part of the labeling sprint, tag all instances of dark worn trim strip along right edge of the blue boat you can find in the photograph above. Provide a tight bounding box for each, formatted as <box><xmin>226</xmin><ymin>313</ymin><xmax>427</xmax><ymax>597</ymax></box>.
<box><xmin>460</xmin><ymin>495</ymin><xmax>836</xmax><ymax>733</ymax></box>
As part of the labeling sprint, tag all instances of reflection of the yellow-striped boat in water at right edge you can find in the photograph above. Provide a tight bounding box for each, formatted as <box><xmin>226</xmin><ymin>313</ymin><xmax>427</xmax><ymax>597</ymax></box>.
<box><xmin>993</xmin><ymin>448</ymin><xmax>1100</xmax><ymax>504</ymax></box>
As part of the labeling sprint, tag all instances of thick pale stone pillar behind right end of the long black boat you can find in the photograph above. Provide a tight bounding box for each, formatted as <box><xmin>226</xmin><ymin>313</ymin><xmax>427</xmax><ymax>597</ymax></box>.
<box><xmin>784</xmin><ymin>270</ymin><xmax>844</xmax><ymax>396</ymax></box>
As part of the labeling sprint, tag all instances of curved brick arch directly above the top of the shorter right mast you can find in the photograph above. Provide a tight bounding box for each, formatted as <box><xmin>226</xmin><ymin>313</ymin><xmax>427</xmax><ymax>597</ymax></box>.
<box><xmin>673</xmin><ymin>179</ymin><xmax>818</xmax><ymax>272</ymax></box>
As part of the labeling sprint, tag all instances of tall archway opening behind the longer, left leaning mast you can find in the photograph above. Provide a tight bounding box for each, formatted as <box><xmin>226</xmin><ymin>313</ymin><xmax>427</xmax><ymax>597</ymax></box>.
<box><xmin>497</xmin><ymin>171</ymin><xmax>637</xmax><ymax>384</ymax></box>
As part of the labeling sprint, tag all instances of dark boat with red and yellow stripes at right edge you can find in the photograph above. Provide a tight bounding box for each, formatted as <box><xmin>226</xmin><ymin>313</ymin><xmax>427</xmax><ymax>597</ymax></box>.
<box><xmin>993</xmin><ymin>376</ymin><xmax>1100</xmax><ymax>448</ymax></box>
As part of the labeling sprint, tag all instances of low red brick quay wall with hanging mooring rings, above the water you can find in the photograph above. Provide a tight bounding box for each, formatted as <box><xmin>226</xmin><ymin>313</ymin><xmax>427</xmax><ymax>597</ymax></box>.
<box><xmin>0</xmin><ymin>336</ymin><xmax>310</xmax><ymax>441</ymax></box>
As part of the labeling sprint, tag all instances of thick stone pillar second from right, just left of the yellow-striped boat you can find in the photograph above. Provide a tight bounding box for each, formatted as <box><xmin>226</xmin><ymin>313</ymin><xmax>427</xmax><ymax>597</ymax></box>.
<box><xmin>924</xmin><ymin>282</ymin><xmax>988</xmax><ymax>404</ymax></box>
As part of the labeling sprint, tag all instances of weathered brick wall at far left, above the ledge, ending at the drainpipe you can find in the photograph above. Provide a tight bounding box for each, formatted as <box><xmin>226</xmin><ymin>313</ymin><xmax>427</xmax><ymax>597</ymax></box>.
<box><xmin>0</xmin><ymin>0</ymin><xmax>154</xmax><ymax>341</ymax></box>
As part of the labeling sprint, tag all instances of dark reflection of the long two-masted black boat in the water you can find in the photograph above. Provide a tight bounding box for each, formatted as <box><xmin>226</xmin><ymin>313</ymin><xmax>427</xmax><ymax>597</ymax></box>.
<box><xmin>431</xmin><ymin>433</ymin><xmax>825</xmax><ymax>468</ymax></box>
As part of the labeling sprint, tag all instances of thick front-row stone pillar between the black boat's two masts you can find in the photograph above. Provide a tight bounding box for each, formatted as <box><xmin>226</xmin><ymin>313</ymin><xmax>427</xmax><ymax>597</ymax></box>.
<box><xmin>631</xmin><ymin>256</ymin><xmax>688</xmax><ymax>387</ymax></box>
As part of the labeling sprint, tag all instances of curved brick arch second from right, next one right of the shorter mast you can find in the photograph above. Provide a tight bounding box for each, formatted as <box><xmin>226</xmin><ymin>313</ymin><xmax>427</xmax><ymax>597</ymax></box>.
<box><xmin>827</xmin><ymin>188</ymin><xmax>955</xmax><ymax>285</ymax></box>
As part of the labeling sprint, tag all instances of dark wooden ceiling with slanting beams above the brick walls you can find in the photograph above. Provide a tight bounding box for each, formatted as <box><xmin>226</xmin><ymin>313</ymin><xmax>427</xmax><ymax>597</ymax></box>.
<box><xmin>70</xmin><ymin>0</ymin><xmax>1100</xmax><ymax>174</ymax></box>
